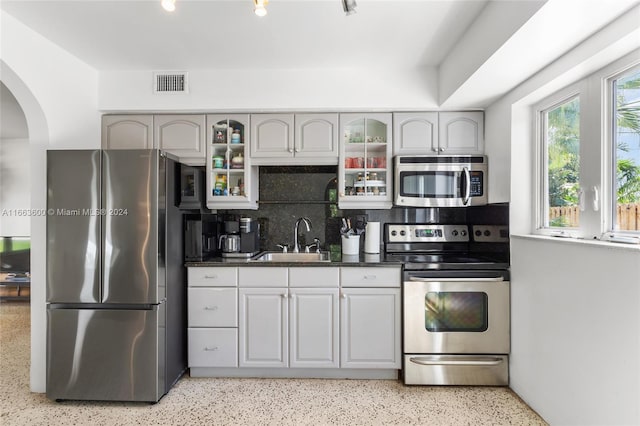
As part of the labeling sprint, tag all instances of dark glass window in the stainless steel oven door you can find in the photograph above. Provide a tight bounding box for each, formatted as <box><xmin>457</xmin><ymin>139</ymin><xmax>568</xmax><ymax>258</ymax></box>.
<box><xmin>425</xmin><ymin>291</ymin><xmax>489</xmax><ymax>332</ymax></box>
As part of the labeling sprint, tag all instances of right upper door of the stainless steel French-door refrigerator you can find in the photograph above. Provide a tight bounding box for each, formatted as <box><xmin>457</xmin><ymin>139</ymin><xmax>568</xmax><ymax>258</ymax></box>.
<box><xmin>101</xmin><ymin>150</ymin><xmax>164</xmax><ymax>303</ymax></box>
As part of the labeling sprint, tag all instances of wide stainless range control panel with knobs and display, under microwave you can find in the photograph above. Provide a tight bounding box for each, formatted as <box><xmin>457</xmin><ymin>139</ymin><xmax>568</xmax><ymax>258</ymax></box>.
<box><xmin>386</xmin><ymin>224</ymin><xmax>469</xmax><ymax>243</ymax></box>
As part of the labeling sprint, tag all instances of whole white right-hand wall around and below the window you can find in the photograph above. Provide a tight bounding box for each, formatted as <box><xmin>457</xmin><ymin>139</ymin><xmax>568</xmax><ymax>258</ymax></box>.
<box><xmin>485</xmin><ymin>7</ymin><xmax>640</xmax><ymax>425</ymax></box>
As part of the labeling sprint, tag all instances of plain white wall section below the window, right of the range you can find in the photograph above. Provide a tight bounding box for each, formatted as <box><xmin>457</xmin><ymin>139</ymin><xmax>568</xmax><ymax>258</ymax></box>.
<box><xmin>510</xmin><ymin>236</ymin><xmax>640</xmax><ymax>425</ymax></box>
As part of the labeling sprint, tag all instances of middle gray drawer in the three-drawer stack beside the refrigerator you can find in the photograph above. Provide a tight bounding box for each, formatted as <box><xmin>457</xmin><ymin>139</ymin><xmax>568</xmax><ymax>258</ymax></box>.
<box><xmin>187</xmin><ymin>287</ymin><xmax>238</xmax><ymax>327</ymax></box>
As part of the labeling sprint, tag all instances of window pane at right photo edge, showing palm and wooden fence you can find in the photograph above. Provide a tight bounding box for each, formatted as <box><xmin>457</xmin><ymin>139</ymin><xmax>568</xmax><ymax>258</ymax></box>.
<box><xmin>610</xmin><ymin>68</ymin><xmax>640</xmax><ymax>232</ymax></box>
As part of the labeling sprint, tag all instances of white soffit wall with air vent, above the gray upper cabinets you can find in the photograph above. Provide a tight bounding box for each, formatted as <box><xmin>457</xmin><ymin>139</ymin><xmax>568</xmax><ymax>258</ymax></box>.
<box><xmin>99</xmin><ymin>67</ymin><xmax>437</xmax><ymax>112</ymax></box>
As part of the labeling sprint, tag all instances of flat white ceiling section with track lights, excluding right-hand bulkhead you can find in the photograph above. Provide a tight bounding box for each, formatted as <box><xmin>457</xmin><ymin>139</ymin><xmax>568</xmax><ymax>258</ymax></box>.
<box><xmin>0</xmin><ymin>0</ymin><xmax>487</xmax><ymax>70</ymax></box>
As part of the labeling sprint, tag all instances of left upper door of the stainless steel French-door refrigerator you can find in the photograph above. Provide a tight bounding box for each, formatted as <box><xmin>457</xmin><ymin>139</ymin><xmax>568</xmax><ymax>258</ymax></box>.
<box><xmin>46</xmin><ymin>150</ymin><xmax>101</xmax><ymax>303</ymax></box>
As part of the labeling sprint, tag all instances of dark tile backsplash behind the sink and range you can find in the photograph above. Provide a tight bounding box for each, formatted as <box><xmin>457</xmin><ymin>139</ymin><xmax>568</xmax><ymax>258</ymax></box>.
<box><xmin>218</xmin><ymin>166</ymin><xmax>508</xmax><ymax>250</ymax></box>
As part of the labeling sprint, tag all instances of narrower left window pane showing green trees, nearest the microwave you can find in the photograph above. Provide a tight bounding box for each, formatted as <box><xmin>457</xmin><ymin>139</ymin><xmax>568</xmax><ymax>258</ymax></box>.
<box><xmin>541</xmin><ymin>96</ymin><xmax>580</xmax><ymax>228</ymax></box>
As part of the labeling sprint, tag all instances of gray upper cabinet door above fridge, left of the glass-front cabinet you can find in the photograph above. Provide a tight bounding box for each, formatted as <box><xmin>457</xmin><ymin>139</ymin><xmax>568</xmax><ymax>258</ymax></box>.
<box><xmin>153</xmin><ymin>114</ymin><xmax>206</xmax><ymax>166</ymax></box>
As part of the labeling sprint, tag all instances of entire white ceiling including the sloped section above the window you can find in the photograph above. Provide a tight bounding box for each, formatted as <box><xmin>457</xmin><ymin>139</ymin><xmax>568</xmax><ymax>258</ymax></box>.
<box><xmin>0</xmin><ymin>0</ymin><xmax>640</xmax><ymax>108</ymax></box>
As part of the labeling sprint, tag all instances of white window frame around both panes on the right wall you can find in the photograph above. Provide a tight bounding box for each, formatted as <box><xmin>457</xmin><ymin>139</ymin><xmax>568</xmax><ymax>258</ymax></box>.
<box><xmin>531</xmin><ymin>54</ymin><xmax>640</xmax><ymax>245</ymax></box>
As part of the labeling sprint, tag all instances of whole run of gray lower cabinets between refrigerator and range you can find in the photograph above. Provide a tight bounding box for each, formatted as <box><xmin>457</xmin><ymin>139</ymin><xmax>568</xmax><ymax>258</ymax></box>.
<box><xmin>188</xmin><ymin>266</ymin><xmax>401</xmax><ymax>378</ymax></box>
